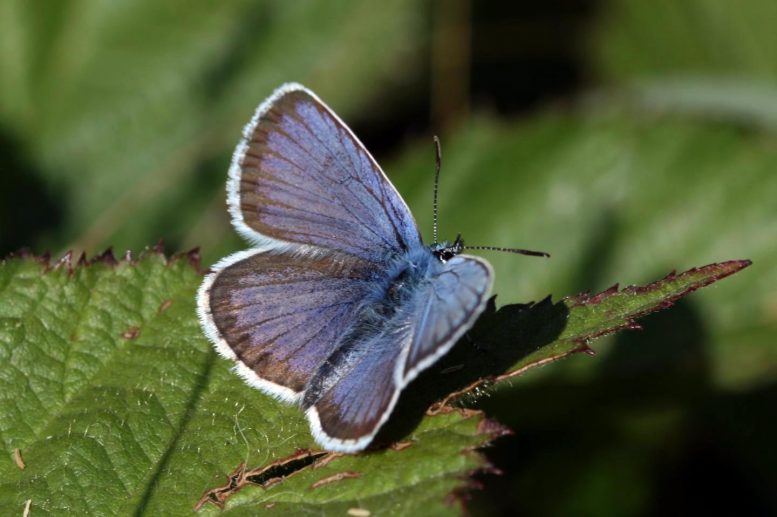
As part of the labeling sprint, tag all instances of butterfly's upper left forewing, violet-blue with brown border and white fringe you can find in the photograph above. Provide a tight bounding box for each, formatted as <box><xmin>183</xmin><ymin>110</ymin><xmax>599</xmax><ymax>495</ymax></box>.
<box><xmin>230</xmin><ymin>85</ymin><xmax>420</xmax><ymax>262</ymax></box>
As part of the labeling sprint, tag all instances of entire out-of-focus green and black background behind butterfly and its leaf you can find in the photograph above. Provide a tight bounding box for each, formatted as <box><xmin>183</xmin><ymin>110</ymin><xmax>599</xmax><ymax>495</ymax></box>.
<box><xmin>0</xmin><ymin>0</ymin><xmax>777</xmax><ymax>515</ymax></box>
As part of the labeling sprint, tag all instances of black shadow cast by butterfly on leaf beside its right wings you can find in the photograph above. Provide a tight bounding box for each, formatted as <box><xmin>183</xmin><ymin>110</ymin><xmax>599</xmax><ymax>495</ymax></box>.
<box><xmin>374</xmin><ymin>296</ymin><xmax>569</xmax><ymax>447</ymax></box>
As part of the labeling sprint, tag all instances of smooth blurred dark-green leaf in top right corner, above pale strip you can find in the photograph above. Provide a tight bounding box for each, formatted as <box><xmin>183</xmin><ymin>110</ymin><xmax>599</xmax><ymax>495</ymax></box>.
<box><xmin>593</xmin><ymin>0</ymin><xmax>777</xmax><ymax>80</ymax></box>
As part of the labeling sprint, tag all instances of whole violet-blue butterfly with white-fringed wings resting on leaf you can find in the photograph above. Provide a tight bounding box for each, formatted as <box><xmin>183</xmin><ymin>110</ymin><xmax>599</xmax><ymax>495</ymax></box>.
<box><xmin>197</xmin><ymin>84</ymin><xmax>541</xmax><ymax>452</ymax></box>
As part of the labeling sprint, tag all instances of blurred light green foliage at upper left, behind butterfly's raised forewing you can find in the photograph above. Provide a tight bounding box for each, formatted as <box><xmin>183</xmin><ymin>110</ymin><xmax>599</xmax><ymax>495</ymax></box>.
<box><xmin>0</xmin><ymin>0</ymin><xmax>422</xmax><ymax>258</ymax></box>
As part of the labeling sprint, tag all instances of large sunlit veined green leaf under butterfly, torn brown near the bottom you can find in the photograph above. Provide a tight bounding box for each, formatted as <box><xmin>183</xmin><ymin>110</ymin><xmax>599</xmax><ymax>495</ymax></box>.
<box><xmin>0</xmin><ymin>252</ymin><xmax>502</xmax><ymax>515</ymax></box>
